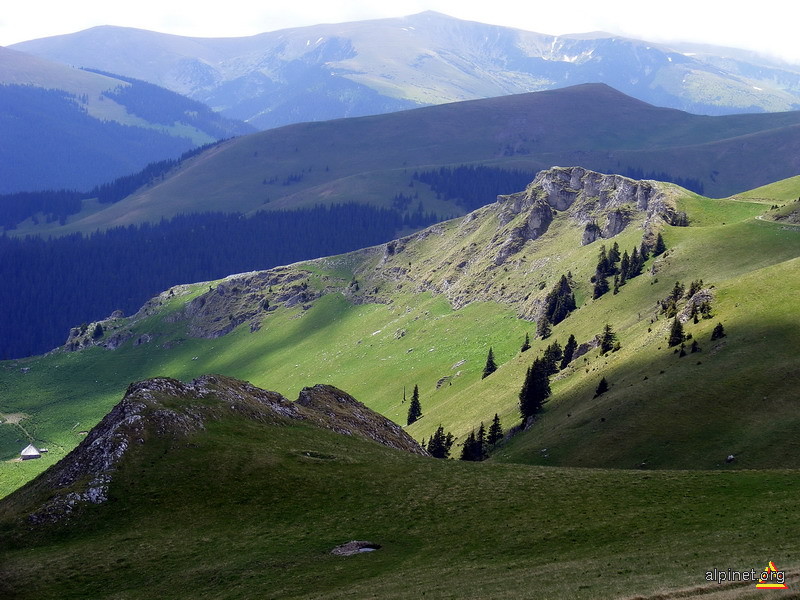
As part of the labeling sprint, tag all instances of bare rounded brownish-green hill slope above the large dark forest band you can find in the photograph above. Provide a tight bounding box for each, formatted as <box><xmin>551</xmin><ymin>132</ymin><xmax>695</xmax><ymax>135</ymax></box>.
<box><xmin>17</xmin><ymin>84</ymin><xmax>800</xmax><ymax>234</ymax></box>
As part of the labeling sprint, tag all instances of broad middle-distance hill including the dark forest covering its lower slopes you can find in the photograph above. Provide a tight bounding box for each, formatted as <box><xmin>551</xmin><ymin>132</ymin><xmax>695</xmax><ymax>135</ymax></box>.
<box><xmin>0</xmin><ymin>84</ymin><xmax>800</xmax><ymax>358</ymax></box>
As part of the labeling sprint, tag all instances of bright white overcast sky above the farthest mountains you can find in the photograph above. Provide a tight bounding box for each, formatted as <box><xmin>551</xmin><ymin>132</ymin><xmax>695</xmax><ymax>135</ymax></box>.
<box><xmin>0</xmin><ymin>0</ymin><xmax>800</xmax><ymax>63</ymax></box>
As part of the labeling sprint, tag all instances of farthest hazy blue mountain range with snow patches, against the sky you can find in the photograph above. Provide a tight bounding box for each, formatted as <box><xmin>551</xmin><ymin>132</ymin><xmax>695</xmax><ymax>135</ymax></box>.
<box><xmin>12</xmin><ymin>11</ymin><xmax>800</xmax><ymax>129</ymax></box>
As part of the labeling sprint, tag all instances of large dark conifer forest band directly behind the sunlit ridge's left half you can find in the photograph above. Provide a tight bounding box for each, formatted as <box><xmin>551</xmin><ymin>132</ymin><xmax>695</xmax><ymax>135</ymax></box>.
<box><xmin>0</xmin><ymin>203</ymin><xmax>438</xmax><ymax>359</ymax></box>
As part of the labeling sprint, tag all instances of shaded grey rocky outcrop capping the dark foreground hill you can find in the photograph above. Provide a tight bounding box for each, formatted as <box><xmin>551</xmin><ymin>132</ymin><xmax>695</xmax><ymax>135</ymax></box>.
<box><xmin>21</xmin><ymin>375</ymin><xmax>427</xmax><ymax>524</ymax></box>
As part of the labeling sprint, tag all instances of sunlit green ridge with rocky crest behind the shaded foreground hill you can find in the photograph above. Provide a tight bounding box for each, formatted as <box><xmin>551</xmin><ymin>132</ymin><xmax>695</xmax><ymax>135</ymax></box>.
<box><xmin>0</xmin><ymin>168</ymin><xmax>800</xmax><ymax>496</ymax></box>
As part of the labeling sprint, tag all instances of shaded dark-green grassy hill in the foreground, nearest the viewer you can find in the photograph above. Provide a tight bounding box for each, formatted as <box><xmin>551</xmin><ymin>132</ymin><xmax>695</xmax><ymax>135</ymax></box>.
<box><xmin>0</xmin><ymin>377</ymin><xmax>800</xmax><ymax>600</ymax></box>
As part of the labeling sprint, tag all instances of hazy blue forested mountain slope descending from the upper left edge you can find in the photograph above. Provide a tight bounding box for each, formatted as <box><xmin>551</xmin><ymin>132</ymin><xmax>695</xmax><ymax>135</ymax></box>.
<box><xmin>0</xmin><ymin>48</ymin><xmax>251</xmax><ymax>193</ymax></box>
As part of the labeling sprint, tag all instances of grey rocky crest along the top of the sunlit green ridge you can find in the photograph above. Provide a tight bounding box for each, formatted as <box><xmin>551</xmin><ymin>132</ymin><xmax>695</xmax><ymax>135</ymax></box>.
<box><xmin>56</xmin><ymin>167</ymin><xmax>683</xmax><ymax>350</ymax></box>
